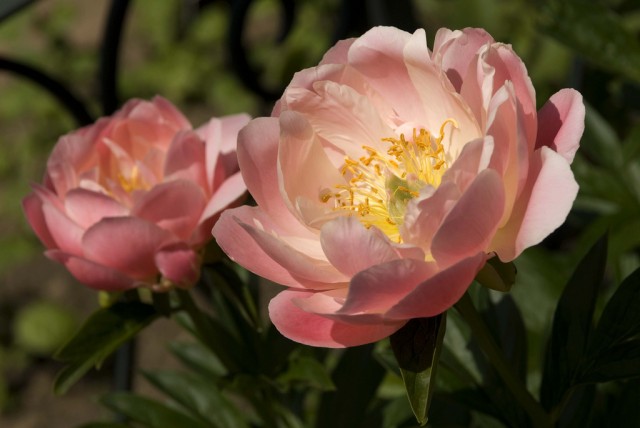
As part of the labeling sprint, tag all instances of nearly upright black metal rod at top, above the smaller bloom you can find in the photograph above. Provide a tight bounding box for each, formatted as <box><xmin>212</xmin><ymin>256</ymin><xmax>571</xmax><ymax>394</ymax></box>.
<box><xmin>100</xmin><ymin>0</ymin><xmax>130</xmax><ymax>115</ymax></box>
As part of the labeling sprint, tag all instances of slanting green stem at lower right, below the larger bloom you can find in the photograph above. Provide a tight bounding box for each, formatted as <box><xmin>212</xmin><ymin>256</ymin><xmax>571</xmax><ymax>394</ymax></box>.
<box><xmin>456</xmin><ymin>293</ymin><xmax>552</xmax><ymax>428</ymax></box>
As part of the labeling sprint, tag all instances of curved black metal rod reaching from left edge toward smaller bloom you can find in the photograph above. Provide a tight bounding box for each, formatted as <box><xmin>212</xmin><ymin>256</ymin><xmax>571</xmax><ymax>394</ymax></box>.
<box><xmin>0</xmin><ymin>57</ymin><xmax>93</xmax><ymax>126</ymax></box>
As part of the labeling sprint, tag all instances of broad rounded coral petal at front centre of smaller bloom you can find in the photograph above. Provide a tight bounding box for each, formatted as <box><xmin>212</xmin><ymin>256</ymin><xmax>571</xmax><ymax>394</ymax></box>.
<box><xmin>82</xmin><ymin>217</ymin><xmax>175</xmax><ymax>280</ymax></box>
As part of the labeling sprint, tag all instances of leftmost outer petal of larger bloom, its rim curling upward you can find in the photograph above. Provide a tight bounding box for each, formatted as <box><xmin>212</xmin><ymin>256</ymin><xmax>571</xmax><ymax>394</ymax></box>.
<box><xmin>213</xmin><ymin>206</ymin><xmax>334</xmax><ymax>288</ymax></box>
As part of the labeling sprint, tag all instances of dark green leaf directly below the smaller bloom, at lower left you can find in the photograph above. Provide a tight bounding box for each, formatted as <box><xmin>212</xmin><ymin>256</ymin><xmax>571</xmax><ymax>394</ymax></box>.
<box><xmin>53</xmin><ymin>302</ymin><xmax>158</xmax><ymax>394</ymax></box>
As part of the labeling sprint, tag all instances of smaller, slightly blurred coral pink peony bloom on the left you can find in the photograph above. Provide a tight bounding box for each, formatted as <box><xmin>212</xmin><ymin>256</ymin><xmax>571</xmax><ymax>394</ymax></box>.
<box><xmin>23</xmin><ymin>97</ymin><xmax>249</xmax><ymax>291</ymax></box>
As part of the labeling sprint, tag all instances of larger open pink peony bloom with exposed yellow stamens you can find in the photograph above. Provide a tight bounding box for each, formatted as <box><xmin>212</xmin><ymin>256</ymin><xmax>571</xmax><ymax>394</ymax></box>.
<box><xmin>213</xmin><ymin>28</ymin><xmax>584</xmax><ymax>347</ymax></box>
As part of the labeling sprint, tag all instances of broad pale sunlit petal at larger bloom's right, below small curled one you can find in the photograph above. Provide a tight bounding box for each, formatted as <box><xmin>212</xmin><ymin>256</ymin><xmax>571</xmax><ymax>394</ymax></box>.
<box><xmin>490</xmin><ymin>146</ymin><xmax>578</xmax><ymax>261</ymax></box>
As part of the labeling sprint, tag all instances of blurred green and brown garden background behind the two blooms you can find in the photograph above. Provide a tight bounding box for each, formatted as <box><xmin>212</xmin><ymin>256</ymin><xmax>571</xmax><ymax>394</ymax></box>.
<box><xmin>0</xmin><ymin>0</ymin><xmax>640</xmax><ymax>427</ymax></box>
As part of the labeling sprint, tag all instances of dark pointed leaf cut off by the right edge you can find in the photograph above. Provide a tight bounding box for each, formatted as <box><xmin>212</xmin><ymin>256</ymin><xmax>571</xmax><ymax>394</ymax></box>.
<box><xmin>589</xmin><ymin>268</ymin><xmax>640</xmax><ymax>355</ymax></box>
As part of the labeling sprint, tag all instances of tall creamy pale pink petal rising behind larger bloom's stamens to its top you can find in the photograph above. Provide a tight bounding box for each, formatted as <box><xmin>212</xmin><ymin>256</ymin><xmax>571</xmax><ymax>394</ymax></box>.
<box><xmin>403</xmin><ymin>29</ymin><xmax>482</xmax><ymax>160</ymax></box>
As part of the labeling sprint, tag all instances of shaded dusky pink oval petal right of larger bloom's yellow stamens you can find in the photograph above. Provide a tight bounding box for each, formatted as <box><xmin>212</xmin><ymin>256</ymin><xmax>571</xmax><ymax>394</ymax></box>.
<box><xmin>431</xmin><ymin>169</ymin><xmax>504</xmax><ymax>267</ymax></box>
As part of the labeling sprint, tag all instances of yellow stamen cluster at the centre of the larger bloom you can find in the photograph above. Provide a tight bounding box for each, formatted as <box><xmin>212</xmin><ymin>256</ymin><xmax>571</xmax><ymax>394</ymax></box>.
<box><xmin>319</xmin><ymin>119</ymin><xmax>458</xmax><ymax>242</ymax></box>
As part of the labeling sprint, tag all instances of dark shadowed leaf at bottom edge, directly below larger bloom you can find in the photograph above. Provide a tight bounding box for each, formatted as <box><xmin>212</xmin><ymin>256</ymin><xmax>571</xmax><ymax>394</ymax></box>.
<box><xmin>314</xmin><ymin>345</ymin><xmax>385</xmax><ymax>428</ymax></box>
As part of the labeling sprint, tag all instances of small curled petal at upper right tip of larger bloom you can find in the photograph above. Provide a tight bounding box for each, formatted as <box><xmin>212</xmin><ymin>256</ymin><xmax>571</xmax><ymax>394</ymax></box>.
<box><xmin>536</xmin><ymin>89</ymin><xmax>585</xmax><ymax>163</ymax></box>
